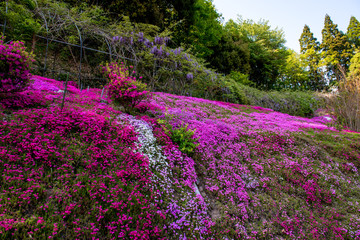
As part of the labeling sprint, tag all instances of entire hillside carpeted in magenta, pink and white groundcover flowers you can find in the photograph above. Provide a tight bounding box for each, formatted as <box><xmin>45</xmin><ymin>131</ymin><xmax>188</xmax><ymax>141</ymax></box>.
<box><xmin>0</xmin><ymin>76</ymin><xmax>360</xmax><ymax>239</ymax></box>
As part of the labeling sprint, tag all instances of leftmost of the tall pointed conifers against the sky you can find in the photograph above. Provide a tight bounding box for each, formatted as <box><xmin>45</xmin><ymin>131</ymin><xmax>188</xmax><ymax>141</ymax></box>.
<box><xmin>299</xmin><ymin>25</ymin><xmax>326</xmax><ymax>91</ymax></box>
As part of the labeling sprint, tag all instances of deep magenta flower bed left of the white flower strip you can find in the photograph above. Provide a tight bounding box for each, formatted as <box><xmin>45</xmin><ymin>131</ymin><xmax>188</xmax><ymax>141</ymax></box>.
<box><xmin>0</xmin><ymin>107</ymin><xmax>165</xmax><ymax>239</ymax></box>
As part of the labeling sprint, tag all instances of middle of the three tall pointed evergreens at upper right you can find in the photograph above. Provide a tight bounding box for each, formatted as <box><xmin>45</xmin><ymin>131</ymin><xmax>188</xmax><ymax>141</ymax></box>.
<box><xmin>320</xmin><ymin>14</ymin><xmax>353</xmax><ymax>84</ymax></box>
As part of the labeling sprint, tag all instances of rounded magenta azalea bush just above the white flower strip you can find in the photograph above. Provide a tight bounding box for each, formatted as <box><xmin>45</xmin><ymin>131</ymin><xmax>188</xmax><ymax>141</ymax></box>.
<box><xmin>102</xmin><ymin>62</ymin><xmax>151</xmax><ymax>112</ymax></box>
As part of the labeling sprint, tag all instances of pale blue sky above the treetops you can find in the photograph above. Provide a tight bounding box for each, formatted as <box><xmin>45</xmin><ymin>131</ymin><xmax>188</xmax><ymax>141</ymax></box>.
<box><xmin>213</xmin><ymin>0</ymin><xmax>360</xmax><ymax>52</ymax></box>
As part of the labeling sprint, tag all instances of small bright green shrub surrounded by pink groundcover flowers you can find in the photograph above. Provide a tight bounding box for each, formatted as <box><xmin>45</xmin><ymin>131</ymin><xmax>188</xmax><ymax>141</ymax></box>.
<box><xmin>157</xmin><ymin>114</ymin><xmax>199</xmax><ymax>156</ymax></box>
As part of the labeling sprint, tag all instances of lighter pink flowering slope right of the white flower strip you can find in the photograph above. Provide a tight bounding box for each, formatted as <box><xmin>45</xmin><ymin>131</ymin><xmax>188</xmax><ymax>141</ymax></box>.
<box><xmin>151</xmin><ymin>93</ymin><xmax>360</xmax><ymax>239</ymax></box>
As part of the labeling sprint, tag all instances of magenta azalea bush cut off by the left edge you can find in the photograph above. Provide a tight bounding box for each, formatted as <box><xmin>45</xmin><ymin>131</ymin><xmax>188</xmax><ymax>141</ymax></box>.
<box><xmin>0</xmin><ymin>38</ymin><xmax>34</xmax><ymax>94</ymax></box>
